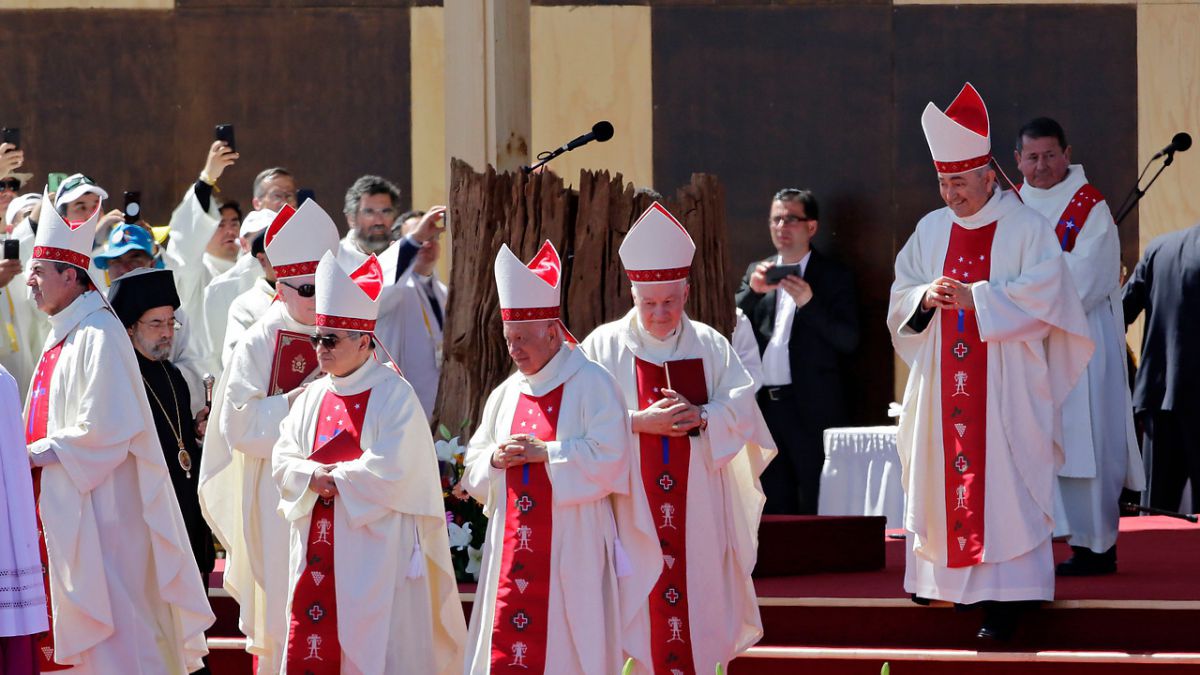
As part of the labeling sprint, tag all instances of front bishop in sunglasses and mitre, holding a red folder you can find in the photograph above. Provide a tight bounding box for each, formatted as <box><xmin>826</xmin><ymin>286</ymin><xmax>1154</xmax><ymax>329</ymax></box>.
<box><xmin>272</xmin><ymin>252</ymin><xmax>467</xmax><ymax>675</ymax></box>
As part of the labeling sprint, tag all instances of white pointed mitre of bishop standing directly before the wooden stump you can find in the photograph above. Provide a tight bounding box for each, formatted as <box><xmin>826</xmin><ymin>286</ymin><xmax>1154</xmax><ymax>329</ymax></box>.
<box><xmin>620</xmin><ymin>202</ymin><xmax>696</xmax><ymax>283</ymax></box>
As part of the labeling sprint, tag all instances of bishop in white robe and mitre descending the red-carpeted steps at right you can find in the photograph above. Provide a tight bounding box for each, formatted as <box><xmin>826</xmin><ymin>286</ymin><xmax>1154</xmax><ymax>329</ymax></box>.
<box><xmin>888</xmin><ymin>84</ymin><xmax>1092</xmax><ymax>639</ymax></box>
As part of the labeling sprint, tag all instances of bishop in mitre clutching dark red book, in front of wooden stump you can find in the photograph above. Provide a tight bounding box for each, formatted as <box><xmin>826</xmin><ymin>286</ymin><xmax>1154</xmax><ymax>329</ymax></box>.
<box><xmin>581</xmin><ymin>202</ymin><xmax>774</xmax><ymax>675</ymax></box>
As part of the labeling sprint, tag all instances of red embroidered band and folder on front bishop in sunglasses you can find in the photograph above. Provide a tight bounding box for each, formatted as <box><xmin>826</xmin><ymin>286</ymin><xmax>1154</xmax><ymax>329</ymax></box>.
<box><xmin>278</xmin><ymin>389</ymin><xmax>371</xmax><ymax>675</ymax></box>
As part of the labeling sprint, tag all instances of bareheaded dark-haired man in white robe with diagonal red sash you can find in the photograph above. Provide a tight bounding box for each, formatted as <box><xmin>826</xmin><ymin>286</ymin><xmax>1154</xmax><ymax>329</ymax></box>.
<box><xmin>1013</xmin><ymin>118</ymin><xmax>1146</xmax><ymax>577</ymax></box>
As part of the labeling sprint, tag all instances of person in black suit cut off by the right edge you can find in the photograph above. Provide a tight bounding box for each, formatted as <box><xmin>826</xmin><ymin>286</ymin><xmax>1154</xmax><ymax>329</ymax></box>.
<box><xmin>1122</xmin><ymin>225</ymin><xmax>1200</xmax><ymax>513</ymax></box>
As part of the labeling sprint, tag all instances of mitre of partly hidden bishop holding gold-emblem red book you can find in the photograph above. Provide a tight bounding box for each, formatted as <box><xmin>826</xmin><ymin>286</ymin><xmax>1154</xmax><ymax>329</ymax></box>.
<box><xmin>263</xmin><ymin>199</ymin><xmax>338</xmax><ymax>279</ymax></box>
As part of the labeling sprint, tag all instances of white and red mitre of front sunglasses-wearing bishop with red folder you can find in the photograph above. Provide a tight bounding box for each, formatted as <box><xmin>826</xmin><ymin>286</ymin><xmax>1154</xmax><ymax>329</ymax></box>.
<box><xmin>310</xmin><ymin>249</ymin><xmax>383</xmax><ymax>333</ymax></box>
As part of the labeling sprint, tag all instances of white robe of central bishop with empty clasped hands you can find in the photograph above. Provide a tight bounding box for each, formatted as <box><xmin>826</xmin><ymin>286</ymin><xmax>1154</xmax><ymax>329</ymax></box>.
<box><xmin>463</xmin><ymin>345</ymin><xmax>662</xmax><ymax>675</ymax></box>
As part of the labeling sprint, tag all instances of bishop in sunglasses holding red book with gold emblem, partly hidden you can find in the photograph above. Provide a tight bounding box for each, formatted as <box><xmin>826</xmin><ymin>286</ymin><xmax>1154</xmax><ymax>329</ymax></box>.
<box><xmin>200</xmin><ymin>199</ymin><xmax>337</xmax><ymax>675</ymax></box>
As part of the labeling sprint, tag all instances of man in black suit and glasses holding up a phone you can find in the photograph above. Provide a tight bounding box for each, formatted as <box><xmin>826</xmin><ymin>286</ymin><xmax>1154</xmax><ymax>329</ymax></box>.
<box><xmin>737</xmin><ymin>189</ymin><xmax>858</xmax><ymax>514</ymax></box>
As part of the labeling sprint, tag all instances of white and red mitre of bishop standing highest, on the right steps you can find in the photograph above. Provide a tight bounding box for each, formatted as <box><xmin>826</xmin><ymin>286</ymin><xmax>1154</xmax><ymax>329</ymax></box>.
<box><xmin>920</xmin><ymin>82</ymin><xmax>991</xmax><ymax>175</ymax></box>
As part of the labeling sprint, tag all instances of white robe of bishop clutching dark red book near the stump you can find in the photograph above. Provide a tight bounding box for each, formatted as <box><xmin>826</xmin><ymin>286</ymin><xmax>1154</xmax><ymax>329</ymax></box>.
<box><xmin>581</xmin><ymin>309</ymin><xmax>774</xmax><ymax>673</ymax></box>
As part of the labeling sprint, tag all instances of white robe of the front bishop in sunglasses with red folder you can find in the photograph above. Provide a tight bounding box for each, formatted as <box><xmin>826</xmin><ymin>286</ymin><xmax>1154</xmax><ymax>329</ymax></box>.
<box><xmin>274</xmin><ymin>358</ymin><xmax>467</xmax><ymax>675</ymax></box>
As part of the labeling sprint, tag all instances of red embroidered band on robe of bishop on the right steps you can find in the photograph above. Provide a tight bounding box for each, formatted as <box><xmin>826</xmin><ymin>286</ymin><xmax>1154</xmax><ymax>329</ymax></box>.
<box><xmin>938</xmin><ymin>222</ymin><xmax>996</xmax><ymax>567</ymax></box>
